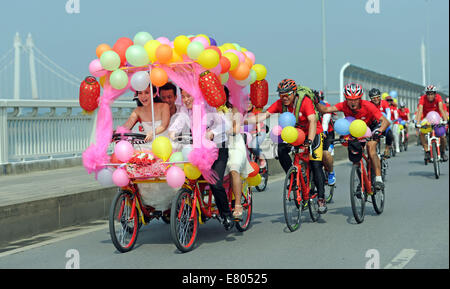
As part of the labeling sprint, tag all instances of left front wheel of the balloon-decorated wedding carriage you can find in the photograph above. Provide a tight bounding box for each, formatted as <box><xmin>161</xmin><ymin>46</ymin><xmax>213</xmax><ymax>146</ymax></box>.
<box><xmin>109</xmin><ymin>189</ymin><xmax>139</xmax><ymax>253</ymax></box>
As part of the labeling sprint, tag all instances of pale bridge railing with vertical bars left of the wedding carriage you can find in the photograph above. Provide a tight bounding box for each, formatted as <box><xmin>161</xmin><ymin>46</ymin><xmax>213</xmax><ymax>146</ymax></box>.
<box><xmin>0</xmin><ymin>99</ymin><xmax>136</xmax><ymax>164</ymax></box>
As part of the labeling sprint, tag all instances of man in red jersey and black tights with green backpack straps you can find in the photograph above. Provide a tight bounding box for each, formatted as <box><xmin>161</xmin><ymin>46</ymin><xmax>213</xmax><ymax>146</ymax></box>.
<box><xmin>247</xmin><ymin>79</ymin><xmax>327</xmax><ymax>213</ymax></box>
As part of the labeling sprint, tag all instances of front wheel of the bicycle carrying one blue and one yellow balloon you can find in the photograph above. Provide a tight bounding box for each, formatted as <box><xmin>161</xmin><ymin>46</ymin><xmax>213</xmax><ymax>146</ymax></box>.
<box><xmin>350</xmin><ymin>163</ymin><xmax>366</xmax><ymax>224</ymax></box>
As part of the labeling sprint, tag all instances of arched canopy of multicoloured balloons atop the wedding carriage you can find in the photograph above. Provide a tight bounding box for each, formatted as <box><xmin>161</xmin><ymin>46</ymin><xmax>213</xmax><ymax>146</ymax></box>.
<box><xmin>89</xmin><ymin>32</ymin><xmax>267</xmax><ymax>91</ymax></box>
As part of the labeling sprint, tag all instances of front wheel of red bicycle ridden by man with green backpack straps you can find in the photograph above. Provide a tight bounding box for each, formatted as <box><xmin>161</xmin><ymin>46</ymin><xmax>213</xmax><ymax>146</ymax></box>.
<box><xmin>283</xmin><ymin>166</ymin><xmax>302</xmax><ymax>232</ymax></box>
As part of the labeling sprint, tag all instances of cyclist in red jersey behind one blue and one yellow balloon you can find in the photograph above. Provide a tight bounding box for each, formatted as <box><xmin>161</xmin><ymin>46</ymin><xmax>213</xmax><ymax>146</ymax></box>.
<box><xmin>318</xmin><ymin>83</ymin><xmax>389</xmax><ymax>190</ymax></box>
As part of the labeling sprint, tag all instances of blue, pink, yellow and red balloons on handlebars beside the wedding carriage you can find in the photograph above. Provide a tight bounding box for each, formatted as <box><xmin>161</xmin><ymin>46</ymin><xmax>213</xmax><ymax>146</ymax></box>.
<box><xmin>270</xmin><ymin>112</ymin><xmax>305</xmax><ymax>146</ymax></box>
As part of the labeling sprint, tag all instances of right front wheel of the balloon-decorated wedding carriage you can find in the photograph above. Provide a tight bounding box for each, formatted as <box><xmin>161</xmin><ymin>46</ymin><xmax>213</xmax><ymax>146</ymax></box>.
<box><xmin>170</xmin><ymin>188</ymin><xmax>198</xmax><ymax>253</ymax></box>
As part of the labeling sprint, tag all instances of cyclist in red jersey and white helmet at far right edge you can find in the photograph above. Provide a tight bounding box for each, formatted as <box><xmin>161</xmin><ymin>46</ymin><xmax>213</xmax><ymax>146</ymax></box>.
<box><xmin>416</xmin><ymin>85</ymin><xmax>448</xmax><ymax>162</ymax></box>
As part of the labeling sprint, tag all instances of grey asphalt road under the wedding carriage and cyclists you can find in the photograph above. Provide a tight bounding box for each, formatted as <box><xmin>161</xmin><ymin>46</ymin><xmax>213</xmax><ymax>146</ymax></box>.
<box><xmin>0</xmin><ymin>146</ymin><xmax>449</xmax><ymax>269</ymax></box>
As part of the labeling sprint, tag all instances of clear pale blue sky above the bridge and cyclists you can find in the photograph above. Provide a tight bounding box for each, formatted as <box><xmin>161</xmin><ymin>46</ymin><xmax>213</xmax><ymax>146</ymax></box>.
<box><xmin>0</xmin><ymin>0</ymin><xmax>449</xmax><ymax>103</ymax></box>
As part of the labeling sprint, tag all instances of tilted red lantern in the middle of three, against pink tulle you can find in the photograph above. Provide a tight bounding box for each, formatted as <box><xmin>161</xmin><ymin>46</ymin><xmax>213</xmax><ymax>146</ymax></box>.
<box><xmin>198</xmin><ymin>70</ymin><xmax>227</xmax><ymax>108</ymax></box>
